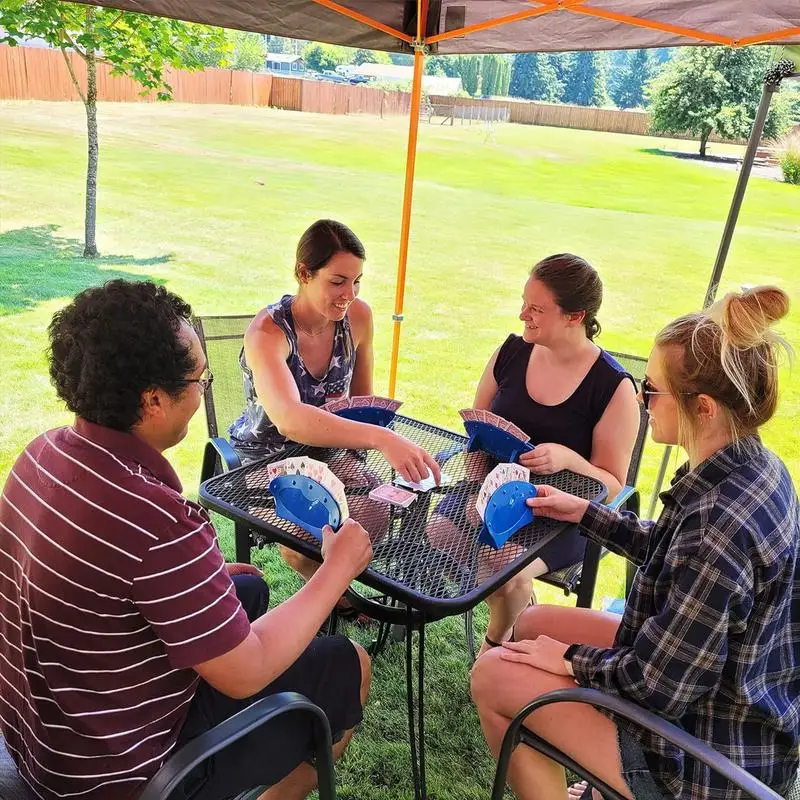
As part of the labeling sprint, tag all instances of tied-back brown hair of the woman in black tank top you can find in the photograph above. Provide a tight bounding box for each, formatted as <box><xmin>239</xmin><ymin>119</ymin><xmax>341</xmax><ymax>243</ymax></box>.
<box><xmin>531</xmin><ymin>253</ymin><xmax>603</xmax><ymax>339</ymax></box>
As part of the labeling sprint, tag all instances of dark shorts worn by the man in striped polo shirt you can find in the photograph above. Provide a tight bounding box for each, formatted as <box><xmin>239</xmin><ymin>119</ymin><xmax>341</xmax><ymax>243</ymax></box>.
<box><xmin>176</xmin><ymin>575</ymin><xmax>362</xmax><ymax>800</ymax></box>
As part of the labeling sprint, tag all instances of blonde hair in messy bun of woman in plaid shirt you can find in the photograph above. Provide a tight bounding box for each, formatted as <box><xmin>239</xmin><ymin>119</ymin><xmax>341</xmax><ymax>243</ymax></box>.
<box><xmin>656</xmin><ymin>286</ymin><xmax>792</xmax><ymax>442</ymax></box>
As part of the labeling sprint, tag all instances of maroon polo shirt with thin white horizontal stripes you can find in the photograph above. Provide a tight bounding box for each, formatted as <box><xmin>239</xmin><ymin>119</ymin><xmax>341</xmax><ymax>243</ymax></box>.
<box><xmin>0</xmin><ymin>419</ymin><xmax>250</xmax><ymax>800</ymax></box>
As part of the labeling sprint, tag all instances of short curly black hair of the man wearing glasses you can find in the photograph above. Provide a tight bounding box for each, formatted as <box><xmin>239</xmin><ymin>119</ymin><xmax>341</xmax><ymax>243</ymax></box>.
<box><xmin>47</xmin><ymin>280</ymin><xmax>197</xmax><ymax>431</ymax></box>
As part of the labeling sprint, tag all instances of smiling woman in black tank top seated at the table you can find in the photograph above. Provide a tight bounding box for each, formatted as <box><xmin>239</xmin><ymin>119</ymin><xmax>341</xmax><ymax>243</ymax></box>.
<box><xmin>428</xmin><ymin>253</ymin><xmax>639</xmax><ymax>650</ymax></box>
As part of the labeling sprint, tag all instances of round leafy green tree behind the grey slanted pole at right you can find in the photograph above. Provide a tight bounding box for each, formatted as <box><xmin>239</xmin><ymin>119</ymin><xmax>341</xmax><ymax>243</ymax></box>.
<box><xmin>647</xmin><ymin>47</ymin><xmax>791</xmax><ymax>157</ymax></box>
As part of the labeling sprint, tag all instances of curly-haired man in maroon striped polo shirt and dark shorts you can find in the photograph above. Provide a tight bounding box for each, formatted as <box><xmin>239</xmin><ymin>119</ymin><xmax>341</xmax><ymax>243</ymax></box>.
<box><xmin>0</xmin><ymin>280</ymin><xmax>371</xmax><ymax>800</ymax></box>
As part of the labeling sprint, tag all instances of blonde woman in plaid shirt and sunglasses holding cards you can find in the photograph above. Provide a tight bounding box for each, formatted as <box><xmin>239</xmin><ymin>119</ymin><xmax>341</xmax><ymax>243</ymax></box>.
<box><xmin>472</xmin><ymin>287</ymin><xmax>800</xmax><ymax>800</ymax></box>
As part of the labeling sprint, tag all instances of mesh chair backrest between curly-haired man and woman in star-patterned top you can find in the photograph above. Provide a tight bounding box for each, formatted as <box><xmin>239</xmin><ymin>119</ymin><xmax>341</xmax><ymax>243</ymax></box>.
<box><xmin>194</xmin><ymin>314</ymin><xmax>255</xmax><ymax>438</ymax></box>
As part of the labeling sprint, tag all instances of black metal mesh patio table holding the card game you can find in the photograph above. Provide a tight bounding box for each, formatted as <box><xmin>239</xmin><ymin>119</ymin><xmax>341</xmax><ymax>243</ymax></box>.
<box><xmin>200</xmin><ymin>416</ymin><xmax>606</xmax><ymax>800</ymax></box>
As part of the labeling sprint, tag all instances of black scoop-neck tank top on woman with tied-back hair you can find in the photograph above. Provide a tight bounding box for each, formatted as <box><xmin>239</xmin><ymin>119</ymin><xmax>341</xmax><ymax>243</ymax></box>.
<box><xmin>491</xmin><ymin>334</ymin><xmax>635</xmax><ymax>461</ymax></box>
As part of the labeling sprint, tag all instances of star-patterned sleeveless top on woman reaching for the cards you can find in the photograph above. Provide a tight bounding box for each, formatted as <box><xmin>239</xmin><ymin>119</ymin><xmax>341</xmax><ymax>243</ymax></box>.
<box><xmin>228</xmin><ymin>294</ymin><xmax>355</xmax><ymax>460</ymax></box>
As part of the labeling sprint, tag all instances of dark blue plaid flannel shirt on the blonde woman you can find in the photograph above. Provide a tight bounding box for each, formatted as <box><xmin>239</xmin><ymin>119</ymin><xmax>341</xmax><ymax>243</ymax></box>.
<box><xmin>572</xmin><ymin>437</ymin><xmax>800</xmax><ymax>800</ymax></box>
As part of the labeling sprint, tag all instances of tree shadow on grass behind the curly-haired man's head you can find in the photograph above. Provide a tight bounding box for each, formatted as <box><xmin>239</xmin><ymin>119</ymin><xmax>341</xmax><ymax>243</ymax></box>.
<box><xmin>0</xmin><ymin>225</ymin><xmax>171</xmax><ymax>316</ymax></box>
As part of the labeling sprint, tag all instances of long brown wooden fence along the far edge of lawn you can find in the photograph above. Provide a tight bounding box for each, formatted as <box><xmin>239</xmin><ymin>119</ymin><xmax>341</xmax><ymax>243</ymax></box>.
<box><xmin>0</xmin><ymin>45</ymin><xmax>740</xmax><ymax>138</ymax></box>
